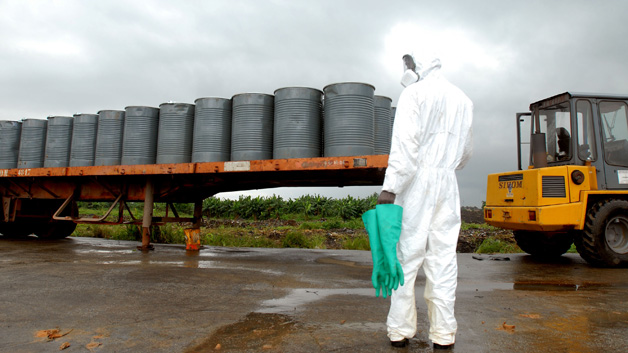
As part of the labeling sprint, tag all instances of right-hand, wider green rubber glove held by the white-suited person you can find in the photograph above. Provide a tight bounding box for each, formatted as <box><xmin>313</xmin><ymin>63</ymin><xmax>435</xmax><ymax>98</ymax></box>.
<box><xmin>375</xmin><ymin>204</ymin><xmax>404</xmax><ymax>293</ymax></box>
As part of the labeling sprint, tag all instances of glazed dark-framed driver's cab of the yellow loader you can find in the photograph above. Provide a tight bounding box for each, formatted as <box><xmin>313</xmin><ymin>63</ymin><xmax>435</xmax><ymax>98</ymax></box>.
<box><xmin>517</xmin><ymin>92</ymin><xmax>628</xmax><ymax>190</ymax></box>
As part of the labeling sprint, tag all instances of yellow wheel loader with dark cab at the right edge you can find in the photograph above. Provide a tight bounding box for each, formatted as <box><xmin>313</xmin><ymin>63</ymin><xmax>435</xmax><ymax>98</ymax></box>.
<box><xmin>484</xmin><ymin>92</ymin><xmax>628</xmax><ymax>267</ymax></box>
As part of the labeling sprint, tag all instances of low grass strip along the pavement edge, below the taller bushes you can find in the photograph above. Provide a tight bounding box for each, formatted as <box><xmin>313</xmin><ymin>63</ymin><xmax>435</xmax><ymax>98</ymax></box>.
<box><xmin>73</xmin><ymin>202</ymin><xmax>516</xmax><ymax>253</ymax></box>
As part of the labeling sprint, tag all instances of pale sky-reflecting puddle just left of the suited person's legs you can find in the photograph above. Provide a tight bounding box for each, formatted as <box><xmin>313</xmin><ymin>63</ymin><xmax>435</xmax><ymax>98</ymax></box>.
<box><xmin>256</xmin><ymin>288</ymin><xmax>375</xmax><ymax>314</ymax></box>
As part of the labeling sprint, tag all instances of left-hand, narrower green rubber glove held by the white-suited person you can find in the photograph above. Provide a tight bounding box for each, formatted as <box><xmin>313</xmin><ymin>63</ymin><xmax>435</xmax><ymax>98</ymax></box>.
<box><xmin>362</xmin><ymin>209</ymin><xmax>390</xmax><ymax>298</ymax></box>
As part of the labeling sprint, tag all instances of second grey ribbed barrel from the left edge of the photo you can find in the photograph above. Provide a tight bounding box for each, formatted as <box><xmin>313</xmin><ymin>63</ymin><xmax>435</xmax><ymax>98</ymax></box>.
<box><xmin>17</xmin><ymin>119</ymin><xmax>48</xmax><ymax>168</ymax></box>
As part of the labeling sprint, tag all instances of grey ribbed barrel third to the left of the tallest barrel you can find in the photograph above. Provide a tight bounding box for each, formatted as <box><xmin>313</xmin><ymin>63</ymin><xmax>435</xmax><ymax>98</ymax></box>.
<box><xmin>192</xmin><ymin>97</ymin><xmax>231</xmax><ymax>163</ymax></box>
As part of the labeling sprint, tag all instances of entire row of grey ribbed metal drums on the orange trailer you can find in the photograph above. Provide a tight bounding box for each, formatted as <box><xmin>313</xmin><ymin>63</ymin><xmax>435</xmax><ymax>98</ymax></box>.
<box><xmin>0</xmin><ymin>82</ymin><xmax>394</xmax><ymax>169</ymax></box>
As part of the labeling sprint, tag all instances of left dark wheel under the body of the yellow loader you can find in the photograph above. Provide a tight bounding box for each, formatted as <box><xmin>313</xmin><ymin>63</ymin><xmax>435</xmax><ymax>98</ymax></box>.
<box><xmin>513</xmin><ymin>230</ymin><xmax>573</xmax><ymax>259</ymax></box>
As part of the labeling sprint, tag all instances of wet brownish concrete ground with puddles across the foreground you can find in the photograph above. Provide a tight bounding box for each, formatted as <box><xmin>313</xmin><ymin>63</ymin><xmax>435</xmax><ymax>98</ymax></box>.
<box><xmin>0</xmin><ymin>237</ymin><xmax>628</xmax><ymax>352</ymax></box>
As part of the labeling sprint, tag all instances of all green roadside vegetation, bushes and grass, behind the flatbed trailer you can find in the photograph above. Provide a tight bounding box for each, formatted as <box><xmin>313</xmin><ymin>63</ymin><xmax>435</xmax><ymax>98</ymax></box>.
<box><xmin>74</xmin><ymin>194</ymin><xmax>524</xmax><ymax>253</ymax></box>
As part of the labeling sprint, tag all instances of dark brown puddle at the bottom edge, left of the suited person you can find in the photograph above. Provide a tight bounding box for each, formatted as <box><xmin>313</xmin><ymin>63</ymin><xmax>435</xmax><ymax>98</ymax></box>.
<box><xmin>185</xmin><ymin>313</ymin><xmax>301</xmax><ymax>353</ymax></box>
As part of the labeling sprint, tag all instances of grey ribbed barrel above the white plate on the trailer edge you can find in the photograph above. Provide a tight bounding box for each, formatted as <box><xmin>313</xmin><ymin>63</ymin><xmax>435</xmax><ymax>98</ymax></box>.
<box><xmin>231</xmin><ymin>93</ymin><xmax>274</xmax><ymax>161</ymax></box>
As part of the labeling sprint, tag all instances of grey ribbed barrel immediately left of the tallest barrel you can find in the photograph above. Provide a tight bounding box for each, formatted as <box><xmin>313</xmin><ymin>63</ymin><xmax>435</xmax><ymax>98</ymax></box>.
<box><xmin>273</xmin><ymin>87</ymin><xmax>323</xmax><ymax>159</ymax></box>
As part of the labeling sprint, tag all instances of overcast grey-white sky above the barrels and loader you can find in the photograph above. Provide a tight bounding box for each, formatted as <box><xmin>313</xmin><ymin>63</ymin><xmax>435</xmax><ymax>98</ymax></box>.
<box><xmin>0</xmin><ymin>0</ymin><xmax>628</xmax><ymax>206</ymax></box>
